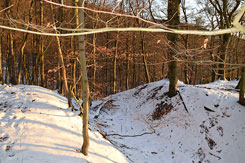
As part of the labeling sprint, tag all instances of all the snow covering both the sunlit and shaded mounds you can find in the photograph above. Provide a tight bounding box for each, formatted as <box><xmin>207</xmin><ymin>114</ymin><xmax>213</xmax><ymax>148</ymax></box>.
<box><xmin>0</xmin><ymin>80</ymin><xmax>245</xmax><ymax>163</ymax></box>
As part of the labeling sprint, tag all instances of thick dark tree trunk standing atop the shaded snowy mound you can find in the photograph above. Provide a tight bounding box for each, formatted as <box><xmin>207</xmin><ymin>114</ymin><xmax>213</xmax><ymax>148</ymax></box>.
<box><xmin>167</xmin><ymin>0</ymin><xmax>180</xmax><ymax>97</ymax></box>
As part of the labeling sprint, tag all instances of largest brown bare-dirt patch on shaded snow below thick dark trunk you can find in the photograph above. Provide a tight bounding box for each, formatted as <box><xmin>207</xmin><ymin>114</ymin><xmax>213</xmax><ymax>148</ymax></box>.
<box><xmin>151</xmin><ymin>101</ymin><xmax>173</xmax><ymax>120</ymax></box>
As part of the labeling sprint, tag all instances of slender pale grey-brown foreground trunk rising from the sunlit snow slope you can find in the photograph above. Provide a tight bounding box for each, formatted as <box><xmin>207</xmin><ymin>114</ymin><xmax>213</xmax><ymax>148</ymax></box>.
<box><xmin>75</xmin><ymin>0</ymin><xmax>89</xmax><ymax>155</ymax></box>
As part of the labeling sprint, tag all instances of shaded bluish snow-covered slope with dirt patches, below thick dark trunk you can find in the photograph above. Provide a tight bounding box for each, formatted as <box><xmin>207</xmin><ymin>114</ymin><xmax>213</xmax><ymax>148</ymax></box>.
<box><xmin>90</xmin><ymin>80</ymin><xmax>245</xmax><ymax>163</ymax></box>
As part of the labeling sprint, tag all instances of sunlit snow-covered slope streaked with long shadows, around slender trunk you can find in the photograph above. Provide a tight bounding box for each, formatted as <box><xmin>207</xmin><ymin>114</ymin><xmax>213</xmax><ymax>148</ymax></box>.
<box><xmin>0</xmin><ymin>85</ymin><xmax>128</xmax><ymax>163</ymax></box>
